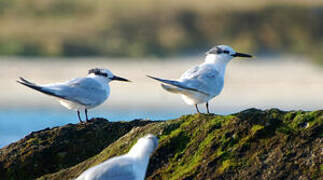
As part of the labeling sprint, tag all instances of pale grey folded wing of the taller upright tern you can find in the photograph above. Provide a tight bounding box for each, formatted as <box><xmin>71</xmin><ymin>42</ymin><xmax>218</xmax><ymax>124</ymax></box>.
<box><xmin>180</xmin><ymin>66</ymin><xmax>223</xmax><ymax>94</ymax></box>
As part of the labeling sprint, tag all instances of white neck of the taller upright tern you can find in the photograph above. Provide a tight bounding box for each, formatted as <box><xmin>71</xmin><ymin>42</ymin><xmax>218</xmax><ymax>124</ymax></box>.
<box><xmin>204</xmin><ymin>54</ymin><xmax>232</xmax><ymax>76</ymax></box>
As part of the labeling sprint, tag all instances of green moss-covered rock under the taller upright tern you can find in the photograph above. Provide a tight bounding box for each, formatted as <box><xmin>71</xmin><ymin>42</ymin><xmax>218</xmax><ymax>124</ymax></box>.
<box><xmin>0</xmin><ymin>109</ymin><xmax>323</xmax><ymax>179</ymax></box>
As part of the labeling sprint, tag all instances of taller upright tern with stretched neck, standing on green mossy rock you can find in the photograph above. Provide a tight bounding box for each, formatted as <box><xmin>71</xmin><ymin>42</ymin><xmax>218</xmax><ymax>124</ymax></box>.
<box><xmin>148</xmin><ymin>45</ymin><xmax>252</xmax><ymax>113</ymax></box>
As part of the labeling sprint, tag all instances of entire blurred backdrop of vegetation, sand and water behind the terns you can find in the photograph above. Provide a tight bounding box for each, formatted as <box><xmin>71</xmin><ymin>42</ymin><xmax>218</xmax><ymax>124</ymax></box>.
<box><xmin>0</xmin><ymin>0</ymin><xmax>323</xmax><ymax>147</ymax></box>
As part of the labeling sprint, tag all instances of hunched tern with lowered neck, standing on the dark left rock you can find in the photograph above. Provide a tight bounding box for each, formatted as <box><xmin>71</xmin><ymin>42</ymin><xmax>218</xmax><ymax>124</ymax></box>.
<box><xmin>17</xmin><ymin>68</ymin><xmax>129</xmax><ymax>123</ymax></box>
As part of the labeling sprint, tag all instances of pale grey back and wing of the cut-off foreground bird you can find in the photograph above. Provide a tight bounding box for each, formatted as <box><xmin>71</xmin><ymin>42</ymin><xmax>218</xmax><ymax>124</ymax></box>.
<box><xmin>77</xmin><ymin>161</ymin><xmax>136</xmax><ymax>180</ymax></box>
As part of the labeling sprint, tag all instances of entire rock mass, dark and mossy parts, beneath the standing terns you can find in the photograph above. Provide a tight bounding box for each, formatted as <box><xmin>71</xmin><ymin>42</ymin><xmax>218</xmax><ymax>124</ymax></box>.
<box><xmin>0</xmin><ymin>109</ymin><xmax>323</xmax><ymax>179</ymax></box>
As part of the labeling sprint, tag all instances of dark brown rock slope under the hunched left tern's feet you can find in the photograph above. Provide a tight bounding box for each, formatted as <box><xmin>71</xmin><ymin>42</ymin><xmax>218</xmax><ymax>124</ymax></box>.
<box><xmin>0</xmin><ymin>118</ymin><xmax>151</xmax><ymax>179</ymax></box>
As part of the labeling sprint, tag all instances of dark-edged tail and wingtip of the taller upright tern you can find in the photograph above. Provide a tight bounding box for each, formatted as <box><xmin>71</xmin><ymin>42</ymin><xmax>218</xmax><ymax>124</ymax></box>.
<box><xmin>147</xmin><ymin>75</ymin><xmax>208</xmax><ymax>96</ymax></box>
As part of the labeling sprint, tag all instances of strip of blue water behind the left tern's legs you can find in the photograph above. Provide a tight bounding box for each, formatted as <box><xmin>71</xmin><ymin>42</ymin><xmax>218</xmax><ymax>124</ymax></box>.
<box><xmin>0</xmin><ymin>108</ymin><xmax>195</xmax><ymax>148</ymax></box>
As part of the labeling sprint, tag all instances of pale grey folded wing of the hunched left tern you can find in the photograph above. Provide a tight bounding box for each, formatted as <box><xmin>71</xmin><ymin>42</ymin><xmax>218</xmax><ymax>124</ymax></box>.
<box><xmin>44</xmin><ymin>78</ymin><xmax>108</xmax><ymax>105</ymax></box>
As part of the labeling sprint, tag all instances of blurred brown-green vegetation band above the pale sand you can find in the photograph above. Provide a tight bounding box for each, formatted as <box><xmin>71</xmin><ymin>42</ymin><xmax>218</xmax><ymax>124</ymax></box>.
<box><xmin>0</xmin><ymin>0</ymin><xmax>323</xmax><ymax>61</ymax></box>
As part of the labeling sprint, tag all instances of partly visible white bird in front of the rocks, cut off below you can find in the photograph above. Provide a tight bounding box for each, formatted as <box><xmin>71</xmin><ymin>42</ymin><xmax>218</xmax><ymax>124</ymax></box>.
<box><xmin>76</xmin><ymin>134</ymin><xmax>158</xmax><ymax>180</ymax></box>
